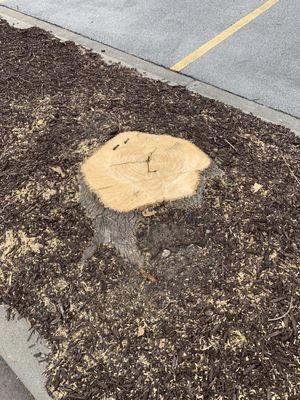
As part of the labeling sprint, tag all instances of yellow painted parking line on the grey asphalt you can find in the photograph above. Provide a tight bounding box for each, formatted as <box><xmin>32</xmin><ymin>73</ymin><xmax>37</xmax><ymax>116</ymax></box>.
<box><xmin>170</xmin><ymin>0</ymin><xmax>280</xmax><ymax>71</ymax></box>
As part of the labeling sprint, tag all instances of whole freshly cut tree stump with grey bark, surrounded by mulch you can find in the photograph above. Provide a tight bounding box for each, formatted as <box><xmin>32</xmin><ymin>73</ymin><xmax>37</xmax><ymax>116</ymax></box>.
<box><xmin>79</xmin><ymin>132</ymin><xmax>217</xmax><ymax>268</ymax></box>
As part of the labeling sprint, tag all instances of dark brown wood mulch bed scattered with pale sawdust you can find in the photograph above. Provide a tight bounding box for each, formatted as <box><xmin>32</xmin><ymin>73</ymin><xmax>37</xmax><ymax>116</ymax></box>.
<box><xmin>0</xmin><ymin>22</ymin><xmax>300</xmax><ymax>400</ymax></box>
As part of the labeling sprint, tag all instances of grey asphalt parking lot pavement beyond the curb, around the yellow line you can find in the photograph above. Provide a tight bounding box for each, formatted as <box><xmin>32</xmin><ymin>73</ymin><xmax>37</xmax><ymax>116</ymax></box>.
<box><xmin>3</xmin><ymin>0</ymin><xmax>300</xmax><ymax>117</ymax></box>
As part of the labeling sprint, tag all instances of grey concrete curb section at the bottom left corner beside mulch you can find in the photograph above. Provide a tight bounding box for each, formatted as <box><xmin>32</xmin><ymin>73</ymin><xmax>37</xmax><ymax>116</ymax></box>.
<box><xmin>0</xmin><ymin>305</ymin><xmax>51</xmax><ymax>400</ymax></box>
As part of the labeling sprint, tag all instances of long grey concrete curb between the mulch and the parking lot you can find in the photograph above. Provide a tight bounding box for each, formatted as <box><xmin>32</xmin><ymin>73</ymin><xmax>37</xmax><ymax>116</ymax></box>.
<box><xmin>0</xmin><ymin>6</ymin><xmax>300</xmax><ymax>136</ymax></box>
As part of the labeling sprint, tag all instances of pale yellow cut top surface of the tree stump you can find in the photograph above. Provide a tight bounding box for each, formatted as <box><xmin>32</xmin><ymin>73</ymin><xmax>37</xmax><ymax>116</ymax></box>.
<box><xmin>81</xmin><ymin>132</ymin><xmax>211</xmax><ymax>212</ymax></box>
